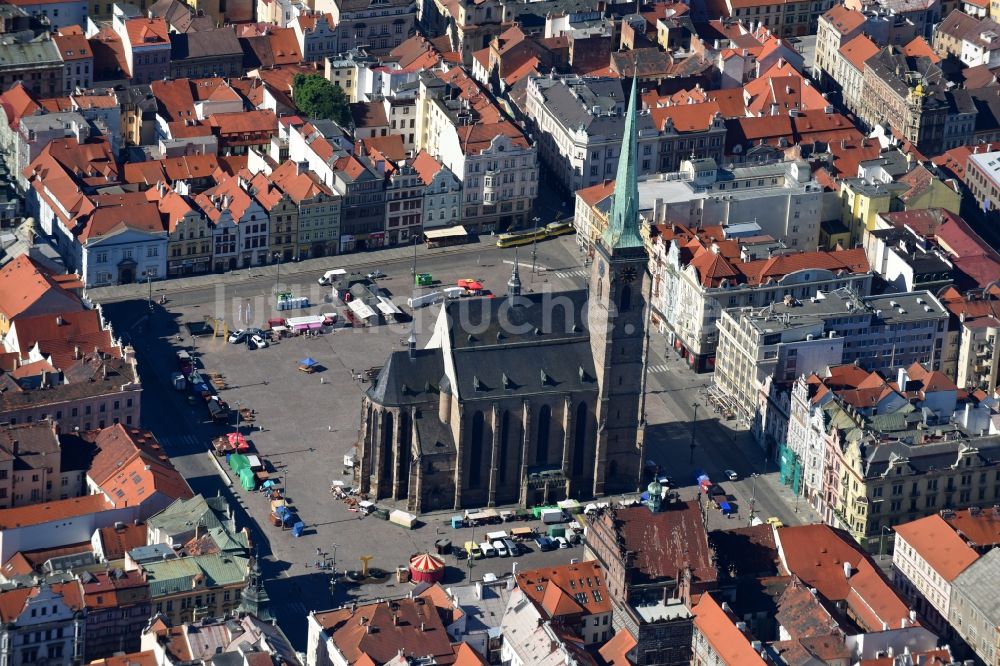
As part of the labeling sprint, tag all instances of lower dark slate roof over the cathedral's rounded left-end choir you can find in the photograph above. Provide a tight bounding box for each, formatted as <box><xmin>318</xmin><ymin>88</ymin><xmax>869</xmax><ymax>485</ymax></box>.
<box><xmin>368</xmin><ymin>349</ymin><xmax>444</xmax><ymax>406</ymax></box>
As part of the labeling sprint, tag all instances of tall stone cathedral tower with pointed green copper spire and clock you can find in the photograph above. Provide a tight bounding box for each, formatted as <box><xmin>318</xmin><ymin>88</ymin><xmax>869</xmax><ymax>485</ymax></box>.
<box><xmin>588</xmin><ymin>77</ymin><xmax>651</xmax><ymax>496</ymax></box>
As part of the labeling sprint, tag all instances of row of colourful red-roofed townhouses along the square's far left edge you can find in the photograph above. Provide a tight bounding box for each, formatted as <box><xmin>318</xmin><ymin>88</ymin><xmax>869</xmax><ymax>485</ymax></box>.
<box><xmin>25</xmin><ymin>123</ymin><xmax>465</xmax><ymax>286</ymax></box>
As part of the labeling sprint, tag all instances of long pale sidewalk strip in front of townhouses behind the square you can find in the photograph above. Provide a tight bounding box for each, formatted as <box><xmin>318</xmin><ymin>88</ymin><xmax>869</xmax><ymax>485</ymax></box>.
<box><xmin>86</xmin><ymin>236</ymin><xmax>488</xmax><ymax>303</ymax></box>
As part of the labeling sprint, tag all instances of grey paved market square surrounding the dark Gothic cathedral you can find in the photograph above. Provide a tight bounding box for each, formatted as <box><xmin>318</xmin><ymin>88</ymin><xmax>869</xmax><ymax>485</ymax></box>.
<box><xmin>97</xmin><ymin>232</ymin><xmax>805</xmax><ymax>645</ymax></box>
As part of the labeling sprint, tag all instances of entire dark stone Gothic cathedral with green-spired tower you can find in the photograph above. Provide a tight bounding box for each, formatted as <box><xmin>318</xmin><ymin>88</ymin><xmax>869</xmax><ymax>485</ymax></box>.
<box><xmin>358</xmin><ymin>80</ymin><xmax>650</xmax><ymax>513</ymax></box>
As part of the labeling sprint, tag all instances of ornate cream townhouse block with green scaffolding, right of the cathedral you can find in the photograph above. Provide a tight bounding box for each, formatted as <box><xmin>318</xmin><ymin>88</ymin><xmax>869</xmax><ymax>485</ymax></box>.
<box><xmin>778</xmin><ymin>363</ymin><xmax>1000</xmax><ymax>552</ymax></box>
